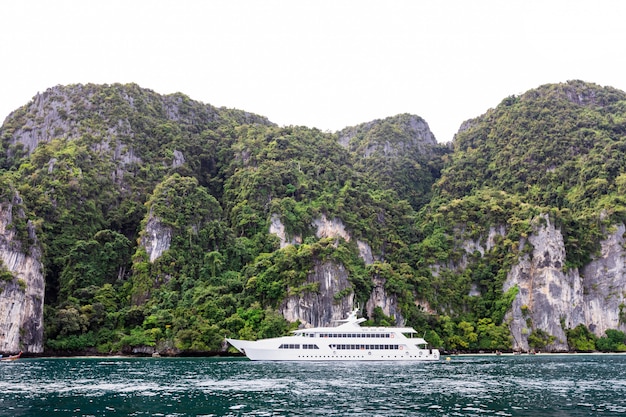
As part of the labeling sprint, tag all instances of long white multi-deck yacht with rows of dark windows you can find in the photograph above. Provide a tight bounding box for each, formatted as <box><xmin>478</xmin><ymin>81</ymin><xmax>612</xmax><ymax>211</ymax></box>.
<box><xmin>226</xmin><ymin>309</ymin><xmax>439</xmax><ymax>361</ymax></box>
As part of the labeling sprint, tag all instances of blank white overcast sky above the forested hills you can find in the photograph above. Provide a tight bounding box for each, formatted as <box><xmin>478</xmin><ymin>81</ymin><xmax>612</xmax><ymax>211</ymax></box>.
<box><xmin>0</xmin><ymin>0</ymin><xmax>626</xmax><ymax>142</ymax></box>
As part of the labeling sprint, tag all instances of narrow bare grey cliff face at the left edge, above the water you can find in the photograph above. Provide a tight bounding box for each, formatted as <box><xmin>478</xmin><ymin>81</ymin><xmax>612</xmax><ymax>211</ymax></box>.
<box><xmin>0</xmin><ymin>194</ymin><xmax>44</xmax><ymax>353</ymax></box>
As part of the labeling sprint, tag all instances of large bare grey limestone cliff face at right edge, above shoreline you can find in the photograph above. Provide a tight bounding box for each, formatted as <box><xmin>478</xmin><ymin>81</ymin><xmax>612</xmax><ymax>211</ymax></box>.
<box><xmin>503</xmin><ymin>216</ymin><xmax>626</xmax><ymax>351</ymax></box>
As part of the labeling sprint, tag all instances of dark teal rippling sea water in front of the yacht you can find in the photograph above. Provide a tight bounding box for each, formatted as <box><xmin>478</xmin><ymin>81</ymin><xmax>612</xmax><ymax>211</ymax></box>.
<box><xmin>0</xmin><ymin>354</ymin><xmax>626</xmax><ymax>417</ymax></box>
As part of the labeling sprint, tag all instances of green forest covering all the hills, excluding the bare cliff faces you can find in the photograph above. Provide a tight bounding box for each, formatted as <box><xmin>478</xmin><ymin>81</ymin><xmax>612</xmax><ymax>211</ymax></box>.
<box><xmin>0</xmin><ymin>82</ymin><xmax>626</xmax><ymax>353</ymax></box>
